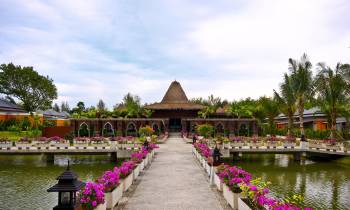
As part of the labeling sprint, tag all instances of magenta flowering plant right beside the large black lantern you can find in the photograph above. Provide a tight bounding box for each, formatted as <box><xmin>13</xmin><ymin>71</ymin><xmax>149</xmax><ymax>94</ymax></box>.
<box><xmin>80</xmin><ymin>182</ymin><xmax>105</xmax><ymax>210</ymax></box>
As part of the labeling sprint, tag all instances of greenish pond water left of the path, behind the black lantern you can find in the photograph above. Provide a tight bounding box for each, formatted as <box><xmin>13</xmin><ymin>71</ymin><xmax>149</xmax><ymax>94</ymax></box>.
<box><xmin>0</xmin><ymin>155</ymin><xmax>117</xmax><ymax>210</ymax></box>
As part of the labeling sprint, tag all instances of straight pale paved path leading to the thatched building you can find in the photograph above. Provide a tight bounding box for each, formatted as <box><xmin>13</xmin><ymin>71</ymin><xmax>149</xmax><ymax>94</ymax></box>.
<box><xmin>120</xmin><ymin>137</ymin><xmax>225</xmax><ymax>210</ymax></box>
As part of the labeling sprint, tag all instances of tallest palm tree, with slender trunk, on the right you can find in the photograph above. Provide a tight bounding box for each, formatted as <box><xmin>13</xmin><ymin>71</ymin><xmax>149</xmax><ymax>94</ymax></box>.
<box><xmin>288</xmin><ymin>53</ymin><xmax>313</xmax><ymax>136</ymax></box>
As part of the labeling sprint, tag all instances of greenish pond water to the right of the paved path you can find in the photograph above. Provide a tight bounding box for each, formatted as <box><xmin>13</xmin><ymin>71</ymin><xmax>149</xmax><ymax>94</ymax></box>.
<box><xmin>226</xmin><ymin>154</ymin><xmax>350</xmax><ymax>210</ymax></box>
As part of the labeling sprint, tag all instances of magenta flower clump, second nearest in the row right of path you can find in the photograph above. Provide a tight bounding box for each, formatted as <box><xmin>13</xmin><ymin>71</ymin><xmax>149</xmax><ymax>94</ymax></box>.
<box><xmin>219</xmin><ymin>165</ymin><xmax>251</xmax><ymax>193</ymax></box>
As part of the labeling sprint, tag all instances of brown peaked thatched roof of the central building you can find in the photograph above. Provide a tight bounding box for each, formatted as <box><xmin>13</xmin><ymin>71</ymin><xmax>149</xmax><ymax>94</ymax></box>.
<box><xmin>146</xmin><ymin>81</ymin><xmax>204</xmax><ymax>110</ymax></box>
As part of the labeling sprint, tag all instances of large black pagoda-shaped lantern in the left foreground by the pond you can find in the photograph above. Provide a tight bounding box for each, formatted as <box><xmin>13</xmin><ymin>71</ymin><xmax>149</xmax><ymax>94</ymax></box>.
<box><xmin>47</xmin><ymin>161</ymin><xmax>85</xmax><ymax>210</ymax></box>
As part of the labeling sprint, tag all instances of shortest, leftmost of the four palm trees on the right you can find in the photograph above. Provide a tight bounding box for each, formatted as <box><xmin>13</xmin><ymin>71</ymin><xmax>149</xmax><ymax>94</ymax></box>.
<box><xmin>259</xmin><ymin>96</ymin><xmax>280</xmax><ymax>134</ymax></box>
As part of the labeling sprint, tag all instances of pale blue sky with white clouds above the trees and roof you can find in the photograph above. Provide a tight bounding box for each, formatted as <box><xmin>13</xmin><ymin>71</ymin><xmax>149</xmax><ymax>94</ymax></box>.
<box><xmin>0</xmin><ymin>0</ymin><xmax>350</xmax><ymax>108</ymax></box>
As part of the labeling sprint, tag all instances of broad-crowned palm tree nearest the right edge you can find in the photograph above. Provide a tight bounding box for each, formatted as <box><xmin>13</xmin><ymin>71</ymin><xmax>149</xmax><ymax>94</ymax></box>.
<box><xmin>315</xmin><ymin>63</ymin><xmax>350</xmax><ymax>139</ymax></box>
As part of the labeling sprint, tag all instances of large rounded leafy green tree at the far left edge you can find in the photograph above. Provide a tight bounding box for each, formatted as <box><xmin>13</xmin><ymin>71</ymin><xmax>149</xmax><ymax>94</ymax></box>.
<box><xmin>0</xmin><ymin>63</ymin><xmax>57</xmax><ymax>112</ymax></box>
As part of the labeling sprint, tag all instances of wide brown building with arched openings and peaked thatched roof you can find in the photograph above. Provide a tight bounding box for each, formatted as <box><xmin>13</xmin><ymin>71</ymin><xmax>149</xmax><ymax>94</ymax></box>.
<box><xmin>71</xmin><ymin>81</ymin><xmax>258</xmax><ymax>136</ymax></box>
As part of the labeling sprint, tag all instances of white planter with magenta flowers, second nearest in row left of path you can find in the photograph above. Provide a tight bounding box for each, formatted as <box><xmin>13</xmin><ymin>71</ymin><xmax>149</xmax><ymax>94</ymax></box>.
<box><xmin>97</xmin><ymin>170</ymin><xmax>123</xmax><ymax>209</ymax></box>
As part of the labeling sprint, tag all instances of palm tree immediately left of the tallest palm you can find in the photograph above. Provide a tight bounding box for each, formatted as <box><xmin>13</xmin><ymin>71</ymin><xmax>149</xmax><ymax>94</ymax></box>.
<box><xmin>273</xmin><ymin>73</ymin><xmax>296</xmax><ymax>136</ymax></box>
